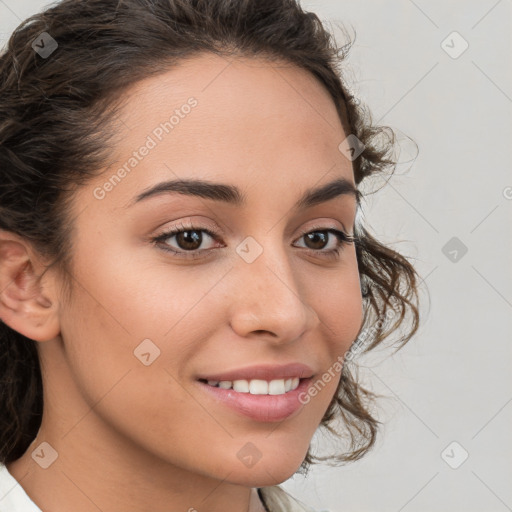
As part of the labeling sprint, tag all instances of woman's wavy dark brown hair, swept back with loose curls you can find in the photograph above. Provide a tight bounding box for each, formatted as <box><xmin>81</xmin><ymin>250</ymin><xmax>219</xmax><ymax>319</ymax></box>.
<box><xmin>0</xmin><ymin>0</ymin><xmax>419</xmax><ymax>472</ymax></box>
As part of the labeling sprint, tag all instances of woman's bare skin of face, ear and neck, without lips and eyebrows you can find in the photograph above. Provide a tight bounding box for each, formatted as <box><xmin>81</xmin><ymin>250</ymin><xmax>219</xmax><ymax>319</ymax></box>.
<box><xmin>0</xmin><ymin>55</ymin><xmax>362</xmax><ymax>512</ymax></box>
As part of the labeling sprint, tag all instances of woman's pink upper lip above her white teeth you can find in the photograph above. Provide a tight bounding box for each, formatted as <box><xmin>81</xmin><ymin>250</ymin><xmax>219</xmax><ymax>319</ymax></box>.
<box><xmin>198</xmin><ymin>363</ymin><xmax>313</xmax><ymax>381</ymax></box>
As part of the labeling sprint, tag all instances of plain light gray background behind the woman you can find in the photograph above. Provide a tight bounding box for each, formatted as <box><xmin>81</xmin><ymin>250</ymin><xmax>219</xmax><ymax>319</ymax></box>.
<box><xmin>0</xmin><ymin>0</ymin><xmax>512</xmax><ymax>512</ymax></box>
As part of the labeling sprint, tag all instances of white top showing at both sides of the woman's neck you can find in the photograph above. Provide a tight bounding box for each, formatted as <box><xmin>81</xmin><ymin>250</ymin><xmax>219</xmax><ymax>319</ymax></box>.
<box><xmin>0</xmin><ymin>464</ymin><xmax>315</xmax><ymax>512</ymax></box>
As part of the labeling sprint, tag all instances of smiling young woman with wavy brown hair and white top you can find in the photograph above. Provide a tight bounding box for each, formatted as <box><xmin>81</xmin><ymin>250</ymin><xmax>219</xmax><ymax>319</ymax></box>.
<box><xmin>0</xmin><ymin>0</ymin><xmax>418</xmax><ymax>512</ymax></box>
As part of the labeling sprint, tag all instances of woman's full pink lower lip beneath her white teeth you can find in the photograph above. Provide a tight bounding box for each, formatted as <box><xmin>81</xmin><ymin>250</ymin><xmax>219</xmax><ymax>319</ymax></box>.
<box><xmin>197</xmin><ymin>378</ymin><xmax>312</xmax><ymax>422</ymax></box>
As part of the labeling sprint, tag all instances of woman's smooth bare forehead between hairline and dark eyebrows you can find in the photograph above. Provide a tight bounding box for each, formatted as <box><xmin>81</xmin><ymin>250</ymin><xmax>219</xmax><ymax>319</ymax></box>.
<box><xmin>85</xmin><ymin>54</ymin><xmax>353</xmax><ymax>216</ymax></box>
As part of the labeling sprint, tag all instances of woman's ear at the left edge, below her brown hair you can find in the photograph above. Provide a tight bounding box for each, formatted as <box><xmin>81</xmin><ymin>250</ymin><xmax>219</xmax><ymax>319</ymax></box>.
<box><xmin>0</xmin><ymin>229</ymin><xmax>60</xmax><ymax>341</ymax></box>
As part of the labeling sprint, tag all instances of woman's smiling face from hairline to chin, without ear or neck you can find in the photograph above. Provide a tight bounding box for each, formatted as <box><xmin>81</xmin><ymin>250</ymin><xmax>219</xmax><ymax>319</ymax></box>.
<box><xmin>40</xmin><ymin>55</ymin><xmax>362</xmax><ymax>486</ymax></box>
